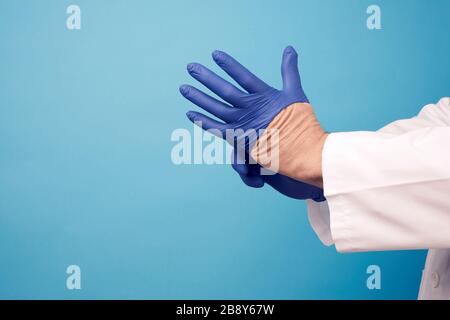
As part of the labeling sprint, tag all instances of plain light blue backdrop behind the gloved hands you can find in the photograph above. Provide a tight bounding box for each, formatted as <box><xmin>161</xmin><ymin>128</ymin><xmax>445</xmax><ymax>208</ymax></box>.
<box><xmin>0</xmin><ymin>0</ymin><xmax>450</xmax><ymax>299</ymax></box>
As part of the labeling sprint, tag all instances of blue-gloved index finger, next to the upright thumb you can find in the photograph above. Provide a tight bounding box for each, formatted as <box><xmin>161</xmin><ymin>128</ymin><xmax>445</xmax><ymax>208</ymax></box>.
<box><xmin>212</xmin><ymin>50</ymin><xmax>270</xmax><ymax>93</ymax></box>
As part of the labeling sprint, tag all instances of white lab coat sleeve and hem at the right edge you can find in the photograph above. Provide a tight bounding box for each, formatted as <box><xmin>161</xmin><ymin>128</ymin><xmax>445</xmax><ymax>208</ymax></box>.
<box><xmin>308</xmin><ymin>98</ymin><xmax>450</xmax><ymax>299</ymax></box>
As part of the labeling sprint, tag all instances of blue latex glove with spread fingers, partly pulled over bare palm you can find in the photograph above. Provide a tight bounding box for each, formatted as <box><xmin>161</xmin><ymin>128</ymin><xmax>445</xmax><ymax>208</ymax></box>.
<box><xmin>180</xmin><ymin>46</ymin><xmax>308</xmax><ymax>153</ymax></box>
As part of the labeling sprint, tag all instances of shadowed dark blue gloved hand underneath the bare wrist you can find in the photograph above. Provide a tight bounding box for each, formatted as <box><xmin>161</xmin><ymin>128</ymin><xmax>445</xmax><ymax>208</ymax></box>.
<box><xmin>232</xmin><ymin>149</ymin><xmax>326</xmax><ymax>202</ymax></box>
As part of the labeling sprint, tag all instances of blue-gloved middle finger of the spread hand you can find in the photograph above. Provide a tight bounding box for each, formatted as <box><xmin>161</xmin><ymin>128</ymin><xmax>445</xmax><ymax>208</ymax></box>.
<box><xmin>187</xmin><ymin>63</ymin><xmax>247</xmax><ymax>106</ymax></box>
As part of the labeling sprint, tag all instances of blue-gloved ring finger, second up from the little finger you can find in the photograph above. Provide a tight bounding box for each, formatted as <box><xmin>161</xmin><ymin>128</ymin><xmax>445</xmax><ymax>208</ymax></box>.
<box><xmin>180</xmin><ymin>85</ymin><xmax>234</xmax><ymax>122</ymax></box>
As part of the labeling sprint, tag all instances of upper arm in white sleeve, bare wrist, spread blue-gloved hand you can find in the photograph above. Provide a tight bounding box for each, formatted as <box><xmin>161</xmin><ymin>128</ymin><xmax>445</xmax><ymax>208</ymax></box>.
<box><xmin>180</xmin><ymin>47</ymin><xmax>450</xmax><ymax>251</ymax></box>
